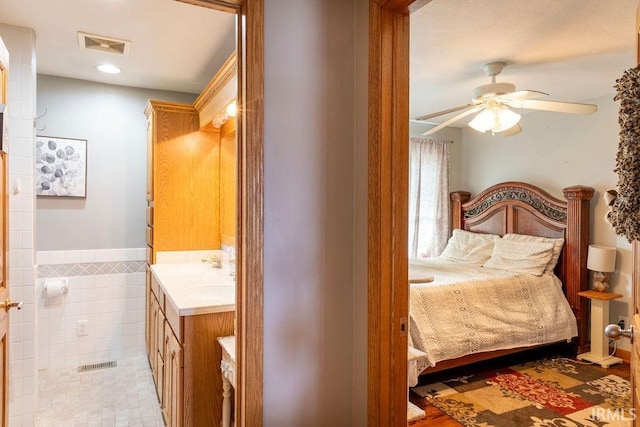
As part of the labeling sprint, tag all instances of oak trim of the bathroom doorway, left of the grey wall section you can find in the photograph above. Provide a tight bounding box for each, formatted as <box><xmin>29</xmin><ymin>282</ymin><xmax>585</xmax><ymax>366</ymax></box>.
<box><xmin>177</xmin><ymin>0</ymin><xmax>264</xmax><ymax>427</ymax></box>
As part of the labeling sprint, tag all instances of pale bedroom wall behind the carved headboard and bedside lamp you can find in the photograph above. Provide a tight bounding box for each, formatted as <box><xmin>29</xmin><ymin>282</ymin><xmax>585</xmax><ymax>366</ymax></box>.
<box><xmin>461</xmin><ymin>93</ymin><xmax>632</xmax><ymax>350</ymax></box>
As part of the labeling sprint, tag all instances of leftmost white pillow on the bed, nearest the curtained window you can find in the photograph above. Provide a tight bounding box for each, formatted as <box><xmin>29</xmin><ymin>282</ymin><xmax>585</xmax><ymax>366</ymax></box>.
<box><xmin>440</xmin><ymin>229</ymin><xmax>500</xmax><ymax>265</ymax></box>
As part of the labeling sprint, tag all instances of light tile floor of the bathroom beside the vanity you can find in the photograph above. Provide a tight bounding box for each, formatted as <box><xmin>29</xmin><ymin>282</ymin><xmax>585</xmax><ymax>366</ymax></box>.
<box><xmin>36</xmin><ymin>356</ymin><xmax>164</xmax><ymax>427</ymax></box>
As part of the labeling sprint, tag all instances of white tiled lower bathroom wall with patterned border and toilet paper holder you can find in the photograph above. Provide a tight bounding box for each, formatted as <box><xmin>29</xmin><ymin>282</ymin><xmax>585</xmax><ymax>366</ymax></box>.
<box><xmin>36</xmin><ymin>248</ymin><xmax>146</xmax><ymax>369</ymax></box>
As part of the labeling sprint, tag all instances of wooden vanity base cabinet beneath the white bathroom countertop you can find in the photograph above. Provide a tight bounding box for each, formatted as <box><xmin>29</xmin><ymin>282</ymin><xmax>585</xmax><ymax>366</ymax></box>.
<box><xmin>148</xmin><ymin>276</ymin><xmax>235</xmax><ymax>427</ymax></box>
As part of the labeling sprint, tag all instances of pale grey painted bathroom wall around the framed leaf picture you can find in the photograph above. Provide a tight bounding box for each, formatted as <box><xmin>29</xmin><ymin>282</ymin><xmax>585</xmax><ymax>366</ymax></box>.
<box><xmin>36</xmin><ymin>75</ymin><xmax>196</xmax><ymax>251</ymax></box>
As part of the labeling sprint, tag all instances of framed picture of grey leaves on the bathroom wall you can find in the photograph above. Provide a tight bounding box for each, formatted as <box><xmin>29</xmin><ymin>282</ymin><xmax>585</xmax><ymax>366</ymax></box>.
<box><xmin>35</xmin><ymin>136</ymin><xmax>87</xmax><ymax>197</ymax></box>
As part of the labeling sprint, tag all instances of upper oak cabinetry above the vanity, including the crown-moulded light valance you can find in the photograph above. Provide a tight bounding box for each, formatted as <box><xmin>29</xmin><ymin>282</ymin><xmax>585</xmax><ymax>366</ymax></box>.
<box><xmin>145</xmin><ymin>54</ymin><xmax>237</xmax><ymax>264</ymax></box>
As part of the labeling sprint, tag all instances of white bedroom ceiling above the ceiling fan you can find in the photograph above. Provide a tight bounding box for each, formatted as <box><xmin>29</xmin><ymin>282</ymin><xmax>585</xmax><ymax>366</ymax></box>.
<box><xmin>410</xmin><ymin>0</ymin><xmax>638</xmax><ymax>126</ymax></box>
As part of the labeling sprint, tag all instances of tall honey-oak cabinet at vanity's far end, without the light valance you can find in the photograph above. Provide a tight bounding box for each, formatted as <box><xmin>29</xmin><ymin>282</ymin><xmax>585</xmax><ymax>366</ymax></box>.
<box><xmin>145</xmin><ymin>101</ymin><xmax>220</xmax><ymax>264</ymax></box>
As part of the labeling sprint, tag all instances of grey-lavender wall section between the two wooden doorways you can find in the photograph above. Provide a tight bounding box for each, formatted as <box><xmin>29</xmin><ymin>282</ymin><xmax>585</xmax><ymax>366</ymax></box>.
<box><xmin>264</xmin><ymin>0</ymin><xmax>358</xmax><ymax>427</ymax></box>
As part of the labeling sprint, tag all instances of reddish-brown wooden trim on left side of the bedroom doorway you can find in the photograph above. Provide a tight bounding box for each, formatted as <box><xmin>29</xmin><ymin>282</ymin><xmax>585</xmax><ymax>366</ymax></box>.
<box><xmin>367</xmin><ymin>0</ymin><xmax>414</xmax><ymax>426</ymax></box>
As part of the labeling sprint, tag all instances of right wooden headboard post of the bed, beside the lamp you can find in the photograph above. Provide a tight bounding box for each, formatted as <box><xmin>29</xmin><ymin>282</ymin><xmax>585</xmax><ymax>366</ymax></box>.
<box><xmin>562</xmin><ymin>185</ymin><xmax>594</xmax><ymax>353</ymax></box>
